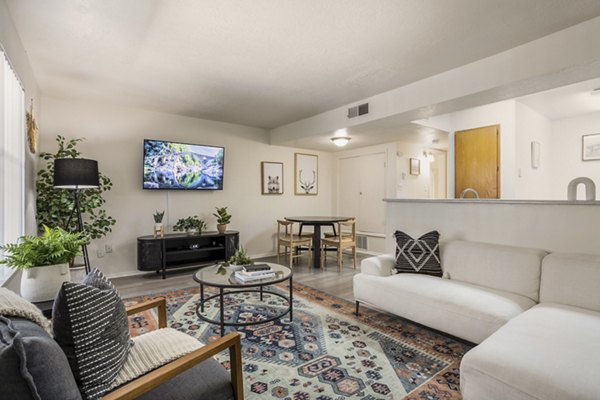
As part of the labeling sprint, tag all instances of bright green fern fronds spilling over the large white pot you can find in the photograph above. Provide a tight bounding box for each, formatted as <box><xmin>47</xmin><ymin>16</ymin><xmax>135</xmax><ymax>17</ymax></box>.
<box><xmin>0</xmin><ymin>225</ymin><xmax>87</xmax><ymax>269</ymax></box>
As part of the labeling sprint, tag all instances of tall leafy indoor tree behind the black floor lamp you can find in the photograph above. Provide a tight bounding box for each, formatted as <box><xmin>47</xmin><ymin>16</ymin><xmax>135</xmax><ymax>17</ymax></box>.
<box><xmin>36</xmin><ymin>135</ymin><xmax>116</xmax><ymax>239</ymax></box>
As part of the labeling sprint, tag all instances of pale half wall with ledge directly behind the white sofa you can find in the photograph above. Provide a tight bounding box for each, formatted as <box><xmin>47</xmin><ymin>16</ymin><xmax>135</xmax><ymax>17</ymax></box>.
<box><xmin>386</xmin><ymin>200</ymin><xmax>600</xmax><ymax>254</ymax></box>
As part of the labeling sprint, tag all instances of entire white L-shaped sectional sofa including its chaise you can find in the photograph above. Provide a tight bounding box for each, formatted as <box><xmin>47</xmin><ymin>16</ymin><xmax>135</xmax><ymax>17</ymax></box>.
<box><xmin>354</xmin><ymin>241</ymin><xmax>600</xmax><ymax>400</ymax></box>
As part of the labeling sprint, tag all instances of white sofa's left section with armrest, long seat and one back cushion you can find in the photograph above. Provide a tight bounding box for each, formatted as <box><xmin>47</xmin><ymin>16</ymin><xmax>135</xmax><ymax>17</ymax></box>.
<box><xmin>354</xmin><ymin>241</ymin><xmax>547</xmax><ymax>343</ymax></box>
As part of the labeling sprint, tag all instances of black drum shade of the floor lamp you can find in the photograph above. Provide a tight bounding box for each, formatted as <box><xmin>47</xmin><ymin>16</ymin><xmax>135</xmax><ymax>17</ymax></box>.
<box><xmin>54</xmin><ymin>158</ymin><xmax>100</xmax><ymax>189</ymax></box>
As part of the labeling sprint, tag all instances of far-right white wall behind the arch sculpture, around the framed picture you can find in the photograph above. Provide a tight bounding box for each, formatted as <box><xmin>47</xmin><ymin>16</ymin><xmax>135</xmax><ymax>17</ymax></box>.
<box><xmin>550</xmin><ymin>112</ymin><xmax>600</xmax><ymax>200</ymax></box>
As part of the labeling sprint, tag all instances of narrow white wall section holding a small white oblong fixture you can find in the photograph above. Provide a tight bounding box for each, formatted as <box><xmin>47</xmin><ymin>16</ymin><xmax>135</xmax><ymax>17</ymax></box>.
<box><xmin>515</xmin><ymin>101</ymin><xmax>552</xmax><ymax>200</ymax></box>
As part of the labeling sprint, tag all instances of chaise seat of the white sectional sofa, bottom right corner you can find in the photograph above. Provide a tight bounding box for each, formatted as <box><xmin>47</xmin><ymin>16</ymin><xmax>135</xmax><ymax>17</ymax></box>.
<box><xmin>460</xmin><ymin>303</ymin><xmax>600</xmax><ymax>400</ymax></box>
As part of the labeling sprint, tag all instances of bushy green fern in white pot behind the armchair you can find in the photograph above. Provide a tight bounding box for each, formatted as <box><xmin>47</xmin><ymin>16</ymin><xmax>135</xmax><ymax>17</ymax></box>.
<box><xmin>0</xmin><ymin>225</ymin><xmax>88</xmax><ymax>302</ymax></box>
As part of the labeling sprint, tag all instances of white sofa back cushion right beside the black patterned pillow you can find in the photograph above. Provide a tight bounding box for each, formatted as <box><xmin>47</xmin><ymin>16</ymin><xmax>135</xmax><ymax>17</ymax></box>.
<box><xmin>441</xmin><ymin>240</ymin><xmax>548</xmax><ymax>302</ymax></box>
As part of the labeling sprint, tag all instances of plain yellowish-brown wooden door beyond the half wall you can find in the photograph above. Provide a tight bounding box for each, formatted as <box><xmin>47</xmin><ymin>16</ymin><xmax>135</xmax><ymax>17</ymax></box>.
<box><xmin>454</xmin><ymin>125</ymin><xmax>500</xmax><ymax>199</ymax></box>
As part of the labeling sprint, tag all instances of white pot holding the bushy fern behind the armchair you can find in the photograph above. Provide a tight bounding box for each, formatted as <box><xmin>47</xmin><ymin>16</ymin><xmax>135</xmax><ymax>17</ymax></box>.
<box><xmin>21</xmin><ymin>264</ymin><xmax>71</xmax><ymax>302</ymax></box>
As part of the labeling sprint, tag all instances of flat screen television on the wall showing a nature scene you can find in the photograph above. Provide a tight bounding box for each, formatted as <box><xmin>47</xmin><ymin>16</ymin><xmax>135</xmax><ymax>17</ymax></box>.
<box><xmin>144</xmin><ymin>139</ymin><xmax>225</xmax><ymax>190</ymax></box>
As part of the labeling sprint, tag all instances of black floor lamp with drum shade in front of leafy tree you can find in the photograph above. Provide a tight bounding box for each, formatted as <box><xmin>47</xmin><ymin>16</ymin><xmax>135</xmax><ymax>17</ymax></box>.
<box><xmin>54</xmin><ymin>158</ymin><xmax>100</xmax><ymax>273</ymax></box>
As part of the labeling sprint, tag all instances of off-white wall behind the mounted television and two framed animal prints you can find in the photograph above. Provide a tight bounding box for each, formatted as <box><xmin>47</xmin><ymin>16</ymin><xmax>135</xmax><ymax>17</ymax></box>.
<box><xmin>41</xmin><ymin>97</ymin><xmax>334</xmax><ymax>276</ymax></box>
